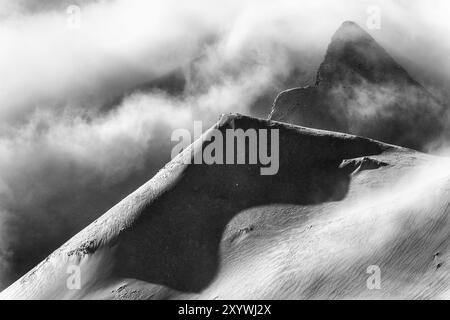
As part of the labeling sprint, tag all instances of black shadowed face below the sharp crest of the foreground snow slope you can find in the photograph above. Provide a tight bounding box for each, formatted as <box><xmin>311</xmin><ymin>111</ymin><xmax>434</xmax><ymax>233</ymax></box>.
<box><xmin>110</xmin><ymin>116</ymin><xmax>386</xmax><ymax>292</ymax></box>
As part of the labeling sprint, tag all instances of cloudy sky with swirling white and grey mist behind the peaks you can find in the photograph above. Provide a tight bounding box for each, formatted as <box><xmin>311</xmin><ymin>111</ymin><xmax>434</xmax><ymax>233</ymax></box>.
<box><xmin>0</xmin><ymin>0</ymin><xmax>450</xmax><ymax>289</ymax></box>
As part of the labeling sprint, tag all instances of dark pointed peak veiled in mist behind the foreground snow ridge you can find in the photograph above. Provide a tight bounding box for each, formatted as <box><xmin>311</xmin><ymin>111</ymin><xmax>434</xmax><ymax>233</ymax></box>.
<box><xmin>269</xmin><ymin>22</ymin><xmax>444</xmax><ymax>150</ymax></box>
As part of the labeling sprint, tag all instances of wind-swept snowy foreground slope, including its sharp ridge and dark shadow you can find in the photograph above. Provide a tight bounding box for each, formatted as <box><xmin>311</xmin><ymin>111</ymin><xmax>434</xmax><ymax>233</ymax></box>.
<box><xmin>0</xmin><ymin>115</ymin><xmax>450</xmax><ymax>299</ymax></box>
